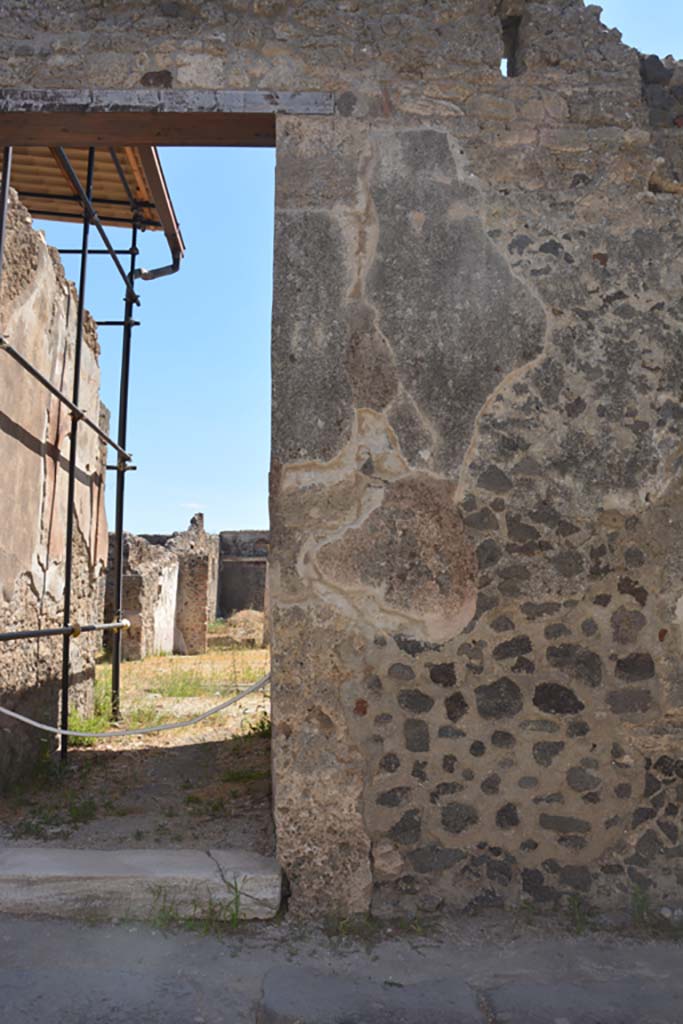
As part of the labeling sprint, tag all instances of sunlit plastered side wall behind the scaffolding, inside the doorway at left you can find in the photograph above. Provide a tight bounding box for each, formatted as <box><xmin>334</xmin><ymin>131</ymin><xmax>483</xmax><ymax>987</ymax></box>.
<box><xmin>0</xmin><ymin>193</ymin><xmax>106</xmax><ymax>790</ymax></box>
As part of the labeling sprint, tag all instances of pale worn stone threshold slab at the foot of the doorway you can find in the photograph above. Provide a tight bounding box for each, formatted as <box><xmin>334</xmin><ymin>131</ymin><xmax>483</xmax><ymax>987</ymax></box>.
<box><xmin>0</xmin><ymin>847</ymin><xmax>282</xmax><ymax>926</ymax></box>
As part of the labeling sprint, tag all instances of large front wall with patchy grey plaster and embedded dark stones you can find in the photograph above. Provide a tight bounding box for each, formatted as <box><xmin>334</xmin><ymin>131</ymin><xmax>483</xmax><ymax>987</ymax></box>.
<box><xmin>6</xmin><ymin>0</ymin><xmax>683</xmax><ymax>913</ymax></box>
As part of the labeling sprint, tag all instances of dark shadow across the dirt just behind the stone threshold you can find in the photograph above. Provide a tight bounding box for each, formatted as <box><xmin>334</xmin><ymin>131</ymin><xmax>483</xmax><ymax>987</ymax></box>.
<box><xmin>0</xmin><ymin>733</ymin><xmax>274</xmax><ymax>855</ymax></box>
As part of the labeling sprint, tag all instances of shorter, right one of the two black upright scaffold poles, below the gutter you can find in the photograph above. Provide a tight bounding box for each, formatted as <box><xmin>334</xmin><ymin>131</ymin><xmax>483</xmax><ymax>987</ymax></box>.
<box><xmin>112</xmin><ymin>220</ymin><xmax>137</xmax><ymax>721</ymax></box>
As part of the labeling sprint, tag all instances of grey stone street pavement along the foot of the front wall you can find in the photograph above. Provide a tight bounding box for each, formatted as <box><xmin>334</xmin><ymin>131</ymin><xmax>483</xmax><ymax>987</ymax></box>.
<box><xmin>0</xmin><ymin>914</ymin><xmax>683</xmax><ymax>1024</ymax></box>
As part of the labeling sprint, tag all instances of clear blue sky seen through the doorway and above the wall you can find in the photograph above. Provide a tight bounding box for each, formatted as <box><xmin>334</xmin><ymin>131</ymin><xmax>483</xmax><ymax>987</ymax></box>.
<box><xmin>41</xmin><ymin>0</ymin><xmax>683</xmax><ymax>534</ymax></box>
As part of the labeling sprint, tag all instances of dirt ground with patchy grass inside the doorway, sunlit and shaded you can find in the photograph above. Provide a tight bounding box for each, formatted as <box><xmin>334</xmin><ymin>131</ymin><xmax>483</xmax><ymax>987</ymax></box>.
<box><xmin>0</xmin><ymin>612</ymin><xmax>273</xmax><ymax>855</ymax></box>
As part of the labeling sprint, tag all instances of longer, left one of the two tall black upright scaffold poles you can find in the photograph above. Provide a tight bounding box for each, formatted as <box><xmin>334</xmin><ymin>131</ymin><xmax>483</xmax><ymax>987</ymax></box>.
<box><xmin>59</xmin><ymin>146</ymin><xmax>95</xmax><ymax>761</ymax></box>
